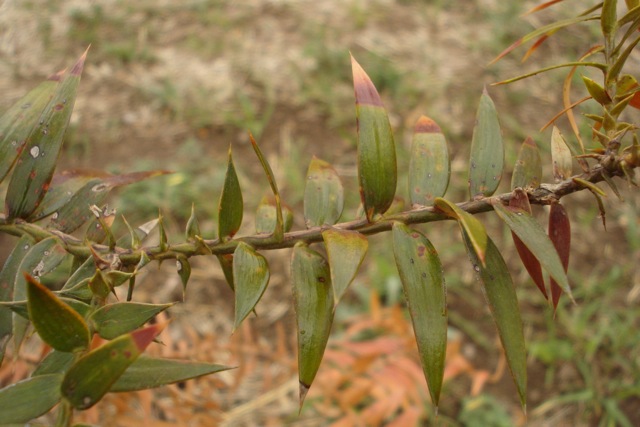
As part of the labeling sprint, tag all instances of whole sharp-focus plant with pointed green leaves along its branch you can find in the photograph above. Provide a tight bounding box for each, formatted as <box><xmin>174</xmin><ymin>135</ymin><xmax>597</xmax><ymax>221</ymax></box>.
<box><xmin>0</xmin><ymin>0</ymin><xmax>640</xmax><ymax>425</ymax></box>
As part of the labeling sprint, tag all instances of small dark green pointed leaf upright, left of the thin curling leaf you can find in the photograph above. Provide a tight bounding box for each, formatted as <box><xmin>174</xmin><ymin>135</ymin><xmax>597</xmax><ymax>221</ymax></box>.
<box><xmin>218</xmin><ymin>146</ymin><xmax>244</xmax><ymax>241</ymax></box>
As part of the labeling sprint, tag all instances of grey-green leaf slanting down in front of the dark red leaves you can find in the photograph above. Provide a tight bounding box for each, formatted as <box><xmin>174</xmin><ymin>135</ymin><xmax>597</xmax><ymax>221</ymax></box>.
<box><xmin>493</xmin><ymin>202</ymin><xmax>573</xmax><ymax>299</ymax></box>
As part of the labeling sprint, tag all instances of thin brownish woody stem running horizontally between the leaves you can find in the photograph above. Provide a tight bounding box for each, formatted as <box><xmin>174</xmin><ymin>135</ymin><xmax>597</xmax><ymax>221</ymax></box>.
<box><xmin>0</xmin><ymin>162</ymin><xmax>636</xmax><ymax>267</ymax></box>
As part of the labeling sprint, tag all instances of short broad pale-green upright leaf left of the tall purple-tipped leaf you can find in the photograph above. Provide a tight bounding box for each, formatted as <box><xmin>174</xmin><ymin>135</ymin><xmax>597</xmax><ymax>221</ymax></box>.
<box><xmin>304</xmin><ymin>156</ymin><xmax>344</xmax><ymax>228</ymax></box>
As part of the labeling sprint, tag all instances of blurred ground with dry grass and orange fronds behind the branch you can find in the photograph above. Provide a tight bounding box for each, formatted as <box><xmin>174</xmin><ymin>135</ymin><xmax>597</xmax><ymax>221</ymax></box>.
<box><xmin>0</xmin><ymin>0</ymin><xmax>640</xmax><ymax>426</ymax></box>
